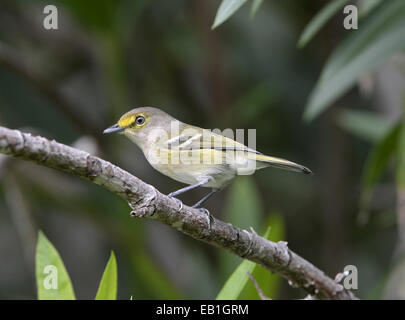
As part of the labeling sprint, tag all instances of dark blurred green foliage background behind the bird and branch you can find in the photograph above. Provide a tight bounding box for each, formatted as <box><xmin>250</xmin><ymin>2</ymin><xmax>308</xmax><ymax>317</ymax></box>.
<box><xmin>0</xmin><ymin>0</ymin><xmax>405</xmax><ymax>299</ymax></box>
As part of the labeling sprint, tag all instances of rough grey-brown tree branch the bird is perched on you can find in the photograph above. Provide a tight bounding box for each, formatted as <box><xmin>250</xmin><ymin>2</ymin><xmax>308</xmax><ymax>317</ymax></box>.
<box><xmin>0</xmin><ymin>127</ymin><xmax>356</xmax><ymax>299</ymax></box>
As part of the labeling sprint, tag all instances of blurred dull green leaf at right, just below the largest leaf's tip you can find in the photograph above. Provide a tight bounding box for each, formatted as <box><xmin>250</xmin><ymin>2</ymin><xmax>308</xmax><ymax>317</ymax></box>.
<box><xmin>336</xmin><ymin>110</ymin><xmax>392</xmax><ymax>142</ymax></box>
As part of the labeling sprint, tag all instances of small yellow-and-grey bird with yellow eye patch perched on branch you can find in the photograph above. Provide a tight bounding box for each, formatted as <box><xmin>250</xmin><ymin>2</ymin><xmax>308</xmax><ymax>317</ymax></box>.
<box><xmin>103</xmin><ymin>107</ymin><xmax>312</xmax><ymax>214</ymax></box>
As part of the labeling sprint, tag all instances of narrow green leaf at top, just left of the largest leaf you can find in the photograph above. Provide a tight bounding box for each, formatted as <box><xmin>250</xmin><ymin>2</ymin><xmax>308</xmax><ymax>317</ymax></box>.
<box><xmin>297</xmin><ymin>0</ymin><xmax>349</xmax><ymax>48</ymax></box>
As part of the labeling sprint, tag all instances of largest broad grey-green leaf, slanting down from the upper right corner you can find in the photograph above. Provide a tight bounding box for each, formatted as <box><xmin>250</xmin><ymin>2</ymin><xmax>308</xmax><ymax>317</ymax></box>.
<box><xmin>304</xmin><ymin>0</ymin><xmax>405</xmax><ymax>121</ymax></box>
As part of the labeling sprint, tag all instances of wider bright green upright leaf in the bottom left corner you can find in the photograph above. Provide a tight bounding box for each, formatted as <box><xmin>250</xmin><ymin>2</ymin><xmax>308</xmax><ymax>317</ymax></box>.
<box><xmin>35</xmin><ymin>231</ymin><xmax>75</xmax><ymax>300</ymax></box>
